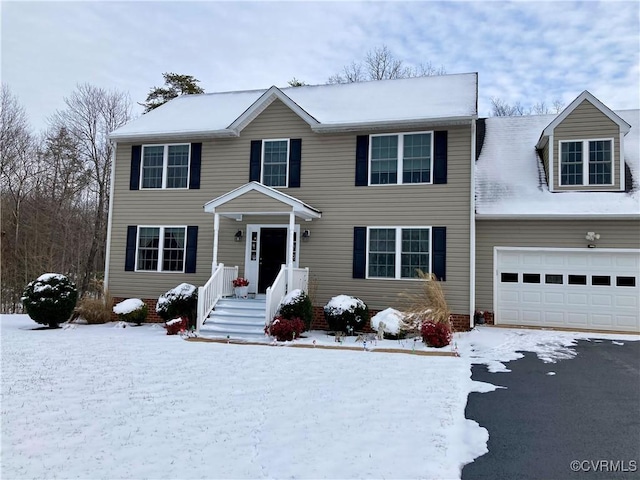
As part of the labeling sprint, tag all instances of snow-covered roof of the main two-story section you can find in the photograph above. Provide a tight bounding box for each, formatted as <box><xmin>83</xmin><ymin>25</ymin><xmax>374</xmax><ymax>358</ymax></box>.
<box><xmin>111</xmin><ymin>73</ymin><xmax>477</xmax><ymax>139</ymax></box>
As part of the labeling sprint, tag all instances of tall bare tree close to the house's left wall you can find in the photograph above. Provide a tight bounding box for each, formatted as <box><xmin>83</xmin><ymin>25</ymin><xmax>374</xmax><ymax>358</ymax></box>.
<box><xmin>51</xmin><ymin>84</ymin><xmax>131</xmax><ymax>293</ymax></box>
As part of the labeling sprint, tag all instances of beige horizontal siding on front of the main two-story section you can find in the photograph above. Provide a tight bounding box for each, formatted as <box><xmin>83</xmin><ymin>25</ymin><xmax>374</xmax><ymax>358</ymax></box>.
<box><xmin>109</xmin><ymin>100</ymin><xmax>471</xmax><ymax>314</ymax></box>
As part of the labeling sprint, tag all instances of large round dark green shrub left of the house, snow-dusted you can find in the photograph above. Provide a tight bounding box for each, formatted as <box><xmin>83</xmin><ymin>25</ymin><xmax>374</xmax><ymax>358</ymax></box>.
<box><xmin>22</xmin><ymin>273</ymin><xmax>78</xmax><ymax>328</ymax></box>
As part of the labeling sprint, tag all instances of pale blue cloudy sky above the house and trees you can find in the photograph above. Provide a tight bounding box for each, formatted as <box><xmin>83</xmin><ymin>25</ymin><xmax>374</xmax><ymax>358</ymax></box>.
<box><xmin>0</xmin><ymin>1</ymin><xmax>640</xmax><ymax>130</ymax></box>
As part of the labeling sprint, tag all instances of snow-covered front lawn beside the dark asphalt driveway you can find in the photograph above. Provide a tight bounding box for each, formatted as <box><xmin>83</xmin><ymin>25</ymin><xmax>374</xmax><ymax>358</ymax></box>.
<box><xmin>0</xmin><ymin>315</ymin><xmax>638</xmax><ymax>479</ymax></box>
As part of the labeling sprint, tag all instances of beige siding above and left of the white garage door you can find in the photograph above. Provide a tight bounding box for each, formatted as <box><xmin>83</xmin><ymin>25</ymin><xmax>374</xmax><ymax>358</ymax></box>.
<box><xmin>476</xmin><ymin>220</ymin><xmax>640</xmax><ymax>310</ymax></box>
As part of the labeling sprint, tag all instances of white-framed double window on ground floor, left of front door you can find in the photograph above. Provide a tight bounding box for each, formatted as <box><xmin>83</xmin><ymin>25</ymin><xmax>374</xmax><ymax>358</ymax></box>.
<box><xmin>136</xmin><ymin>227</ymin><xmax>186</xmax><ymax>272</ymax></box>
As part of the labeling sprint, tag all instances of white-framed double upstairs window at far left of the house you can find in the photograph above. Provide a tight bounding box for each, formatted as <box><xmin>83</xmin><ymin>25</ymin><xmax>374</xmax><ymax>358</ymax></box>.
<box><xmin>140</xmin><ymin>144</ymin><xmax>190</xmax><ymax>189</ymax></box>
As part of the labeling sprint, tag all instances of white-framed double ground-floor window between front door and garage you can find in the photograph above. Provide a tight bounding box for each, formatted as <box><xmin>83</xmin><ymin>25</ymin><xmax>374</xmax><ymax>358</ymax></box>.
<box><xmin>367</xmin><ymin>227</ymin><xmax>431</xmax><ymax>279</ymax></box>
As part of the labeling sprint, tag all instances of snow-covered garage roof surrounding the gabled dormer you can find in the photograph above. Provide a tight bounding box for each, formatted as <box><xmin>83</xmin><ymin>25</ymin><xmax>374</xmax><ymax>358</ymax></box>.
<box><xmin>476</xmin><ymin>110</ymin><xmax>640</xmax><ymax>217</ymax></box>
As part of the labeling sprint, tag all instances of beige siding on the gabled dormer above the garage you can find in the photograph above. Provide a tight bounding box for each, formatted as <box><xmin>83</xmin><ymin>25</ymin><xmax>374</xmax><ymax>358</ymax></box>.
<box><xmin>553</xmin><ymin>100</ymin><xmax>621</xmax><ymax>191</ymax></box>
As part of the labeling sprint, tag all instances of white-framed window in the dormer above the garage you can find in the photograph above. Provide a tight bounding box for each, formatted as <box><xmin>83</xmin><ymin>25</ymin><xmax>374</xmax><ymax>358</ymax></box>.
<box><xmin>560</xmin><ymin>139</ymin><xmax>613</xmax><ymax>186</ymax></box>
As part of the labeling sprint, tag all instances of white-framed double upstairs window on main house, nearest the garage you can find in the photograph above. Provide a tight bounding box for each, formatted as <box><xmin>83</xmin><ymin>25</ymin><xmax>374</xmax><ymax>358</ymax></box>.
<box><xmin>369</xmin><ymin>132</ymin><xmax>433</xmax><ymax>185</ymax></box>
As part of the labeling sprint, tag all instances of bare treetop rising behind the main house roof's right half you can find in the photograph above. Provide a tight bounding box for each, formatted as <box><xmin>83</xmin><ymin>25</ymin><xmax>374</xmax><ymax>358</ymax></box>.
<box><xmin>327</xmin><ymin>45</ymin><xmax>446</xmax><ymax>84</ymax></box>
